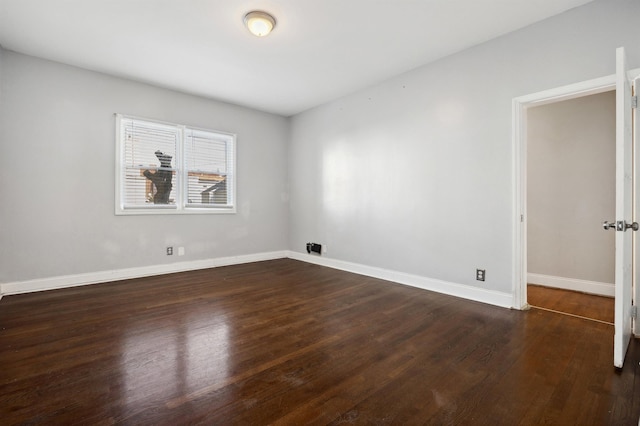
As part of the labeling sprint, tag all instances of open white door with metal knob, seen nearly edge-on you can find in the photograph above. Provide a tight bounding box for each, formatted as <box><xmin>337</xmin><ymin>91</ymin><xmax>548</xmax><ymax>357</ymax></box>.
<box><xmin>605</xmin><ymin>47</ymin><xmax>637</xmax><ymax>368</ymax></box>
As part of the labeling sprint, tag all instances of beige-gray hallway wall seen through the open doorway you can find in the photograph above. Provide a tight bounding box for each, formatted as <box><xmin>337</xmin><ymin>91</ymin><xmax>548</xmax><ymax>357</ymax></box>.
<box><xmin>527</xmin><ymin>91</ymin><xmax>616</xmax><ymax>283</ymax></box>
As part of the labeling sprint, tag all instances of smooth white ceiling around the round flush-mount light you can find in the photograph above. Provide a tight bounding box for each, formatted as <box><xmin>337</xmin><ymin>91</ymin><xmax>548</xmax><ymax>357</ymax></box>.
<box><xmin>0</xmin><ymin>0</ymin><xmax>591</xmax><ymax>116</ymax></box>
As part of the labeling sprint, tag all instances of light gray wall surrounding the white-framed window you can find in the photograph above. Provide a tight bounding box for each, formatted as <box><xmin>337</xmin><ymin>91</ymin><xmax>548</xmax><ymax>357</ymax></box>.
<box><xmin>0</xmin><ymin>51</ymin><xmax>289</xmax><ymax>282</ymax></box>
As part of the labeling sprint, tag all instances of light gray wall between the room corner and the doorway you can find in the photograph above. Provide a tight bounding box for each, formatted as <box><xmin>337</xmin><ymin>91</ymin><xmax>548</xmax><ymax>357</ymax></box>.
<box><xmin>289</xmin><ymin>0</ymin><xmax>640</xmax><ymax>293</ymax></box>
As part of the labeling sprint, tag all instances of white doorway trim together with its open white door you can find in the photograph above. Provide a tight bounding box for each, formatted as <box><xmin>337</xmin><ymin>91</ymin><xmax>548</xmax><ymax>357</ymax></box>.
<box><xmin>512</xmin><ymin>52</ymin><xmax>640</xmax><ymax>368</ymax></box>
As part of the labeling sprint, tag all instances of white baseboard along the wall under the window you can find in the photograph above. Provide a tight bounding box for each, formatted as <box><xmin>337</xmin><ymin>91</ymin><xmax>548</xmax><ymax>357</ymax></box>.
<box><xmin>0</xmin><ymin>251</ymin><xmax>287</xmax><ymax>297</ymax></box>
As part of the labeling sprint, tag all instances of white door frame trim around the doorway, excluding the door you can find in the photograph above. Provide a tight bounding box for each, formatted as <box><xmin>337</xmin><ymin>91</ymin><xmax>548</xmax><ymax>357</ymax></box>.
<box><xmin>511</xmin><ymin>69</ymin><xmax>640</xmax><ymax>314</ymax></box>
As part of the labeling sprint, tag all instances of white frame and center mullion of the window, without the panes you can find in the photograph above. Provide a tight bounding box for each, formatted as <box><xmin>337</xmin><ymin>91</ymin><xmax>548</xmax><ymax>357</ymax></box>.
<box><xmin>115</xmin><ymin>114</ymin><xmax>236</xmax><ymax>215</ymax></box>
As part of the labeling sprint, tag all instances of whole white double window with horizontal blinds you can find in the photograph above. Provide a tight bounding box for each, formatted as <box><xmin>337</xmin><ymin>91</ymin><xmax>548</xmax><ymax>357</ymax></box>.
<box><xmin>116</xmin><ymin>114</ymin><xmax>235</xmax><ymax>214</ymax></box>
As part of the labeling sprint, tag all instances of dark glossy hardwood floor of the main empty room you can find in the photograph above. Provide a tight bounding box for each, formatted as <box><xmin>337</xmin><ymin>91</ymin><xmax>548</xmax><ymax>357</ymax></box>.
<box><xmin>0</xmin><ymin>259</ymin><xmax>640</xmax><ymax>426</ymax></box>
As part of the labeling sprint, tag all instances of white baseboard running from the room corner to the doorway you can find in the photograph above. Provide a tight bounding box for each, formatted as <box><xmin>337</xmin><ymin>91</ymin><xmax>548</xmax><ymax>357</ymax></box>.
<box><xmin>287</xmin><ymin>251</ymin><xmax>513</xmax><ymax>308</ymax></box>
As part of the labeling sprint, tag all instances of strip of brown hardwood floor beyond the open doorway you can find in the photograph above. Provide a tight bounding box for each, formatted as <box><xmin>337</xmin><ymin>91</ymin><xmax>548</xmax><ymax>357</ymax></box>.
<box><xmin>527</xmin><ymin>284</ymin><xmax>614</xmax><ymax>324</ymax></box>
